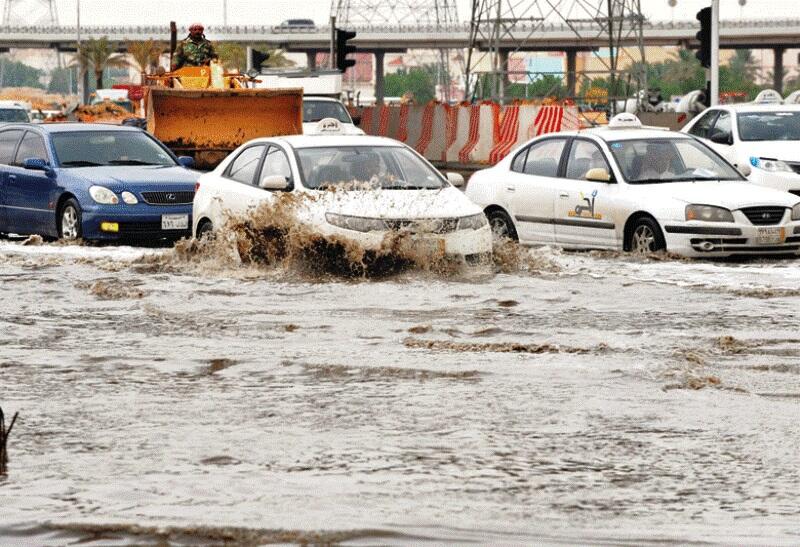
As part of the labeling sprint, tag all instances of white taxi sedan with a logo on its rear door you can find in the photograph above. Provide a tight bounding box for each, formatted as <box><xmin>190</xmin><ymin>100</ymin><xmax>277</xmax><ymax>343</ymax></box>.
<box><xmin>467</xmin><ymin>114</ymin><xmax>800</xmax><ymax>256</ymax></box>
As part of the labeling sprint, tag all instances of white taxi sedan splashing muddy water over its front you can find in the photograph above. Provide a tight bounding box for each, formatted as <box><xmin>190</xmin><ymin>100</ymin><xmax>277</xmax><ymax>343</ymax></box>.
<box><xmin>193</xmin><ymin>127</ymin><xmax>492</xmax><ymax>265</ymax></box>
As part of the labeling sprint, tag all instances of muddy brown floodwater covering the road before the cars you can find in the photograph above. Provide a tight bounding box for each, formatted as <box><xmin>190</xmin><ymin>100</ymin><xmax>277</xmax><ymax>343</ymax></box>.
<box><xmin>0</xmin><ymin>238</ymin><xmax>800</xmax><ymax>545</ymax></box>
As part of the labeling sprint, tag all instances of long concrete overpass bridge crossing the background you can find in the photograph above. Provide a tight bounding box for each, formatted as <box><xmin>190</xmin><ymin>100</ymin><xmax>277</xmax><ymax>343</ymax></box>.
<box><xmin>0</xmin><ymin>17</ymin><xmax>800</xmax><ymax>97</ymax></box>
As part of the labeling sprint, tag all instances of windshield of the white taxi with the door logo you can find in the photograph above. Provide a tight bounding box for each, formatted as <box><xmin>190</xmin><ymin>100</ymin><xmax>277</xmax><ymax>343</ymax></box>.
<box><xmin>608</xmin><ymin>139</ymin><xmax>744</xmax><ymax>184</ymax></box>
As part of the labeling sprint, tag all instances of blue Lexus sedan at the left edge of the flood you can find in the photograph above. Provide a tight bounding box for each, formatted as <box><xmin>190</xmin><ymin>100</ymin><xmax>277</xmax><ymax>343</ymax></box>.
<box><xmin>0</xmin><ymin>123</ymin><xmax>198</xmax><ymax>244</ymax></box>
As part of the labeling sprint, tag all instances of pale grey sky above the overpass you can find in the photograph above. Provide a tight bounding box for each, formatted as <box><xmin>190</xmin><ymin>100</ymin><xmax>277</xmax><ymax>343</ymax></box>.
<box><xmin>34</xmin><ymin>0</ymin><xmax>800</xmax><ymax>25</ymax></box>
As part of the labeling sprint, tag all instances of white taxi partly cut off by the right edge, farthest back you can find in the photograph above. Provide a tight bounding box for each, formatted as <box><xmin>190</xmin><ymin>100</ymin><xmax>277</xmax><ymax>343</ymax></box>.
<box><xmin>681</xmin><ymin>103</ymin><xmax>800</xmax><ymax>196</ymax></box>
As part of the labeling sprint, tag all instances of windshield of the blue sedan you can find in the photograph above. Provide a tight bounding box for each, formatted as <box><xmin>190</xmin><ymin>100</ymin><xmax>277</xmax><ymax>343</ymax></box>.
<box><xmin>52</xmin><ymin>129</ymin><xmax>176</xmax><ymax>167</ymax></box>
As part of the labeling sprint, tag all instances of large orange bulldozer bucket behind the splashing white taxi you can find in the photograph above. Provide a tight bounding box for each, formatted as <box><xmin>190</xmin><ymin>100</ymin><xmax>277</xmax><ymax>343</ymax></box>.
<box><xmin>146</xmin><ymin>87</ymin><xmax>303</xmax><ymax>169</ymax></box>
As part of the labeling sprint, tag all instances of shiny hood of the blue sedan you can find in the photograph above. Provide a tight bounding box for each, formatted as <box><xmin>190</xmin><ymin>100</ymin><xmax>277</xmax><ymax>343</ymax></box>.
<box><xmin>64</xmin><ymin>165</ymin><xmax>200</xmax><ymax>192</ymax></box>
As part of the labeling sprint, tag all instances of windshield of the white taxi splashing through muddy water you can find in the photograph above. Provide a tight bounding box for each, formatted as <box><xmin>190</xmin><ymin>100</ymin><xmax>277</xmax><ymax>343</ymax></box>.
<box><xmin>297</xmin><ymin>146</ymin><xmax>447</xmax><ymax>190</ymax></box>
